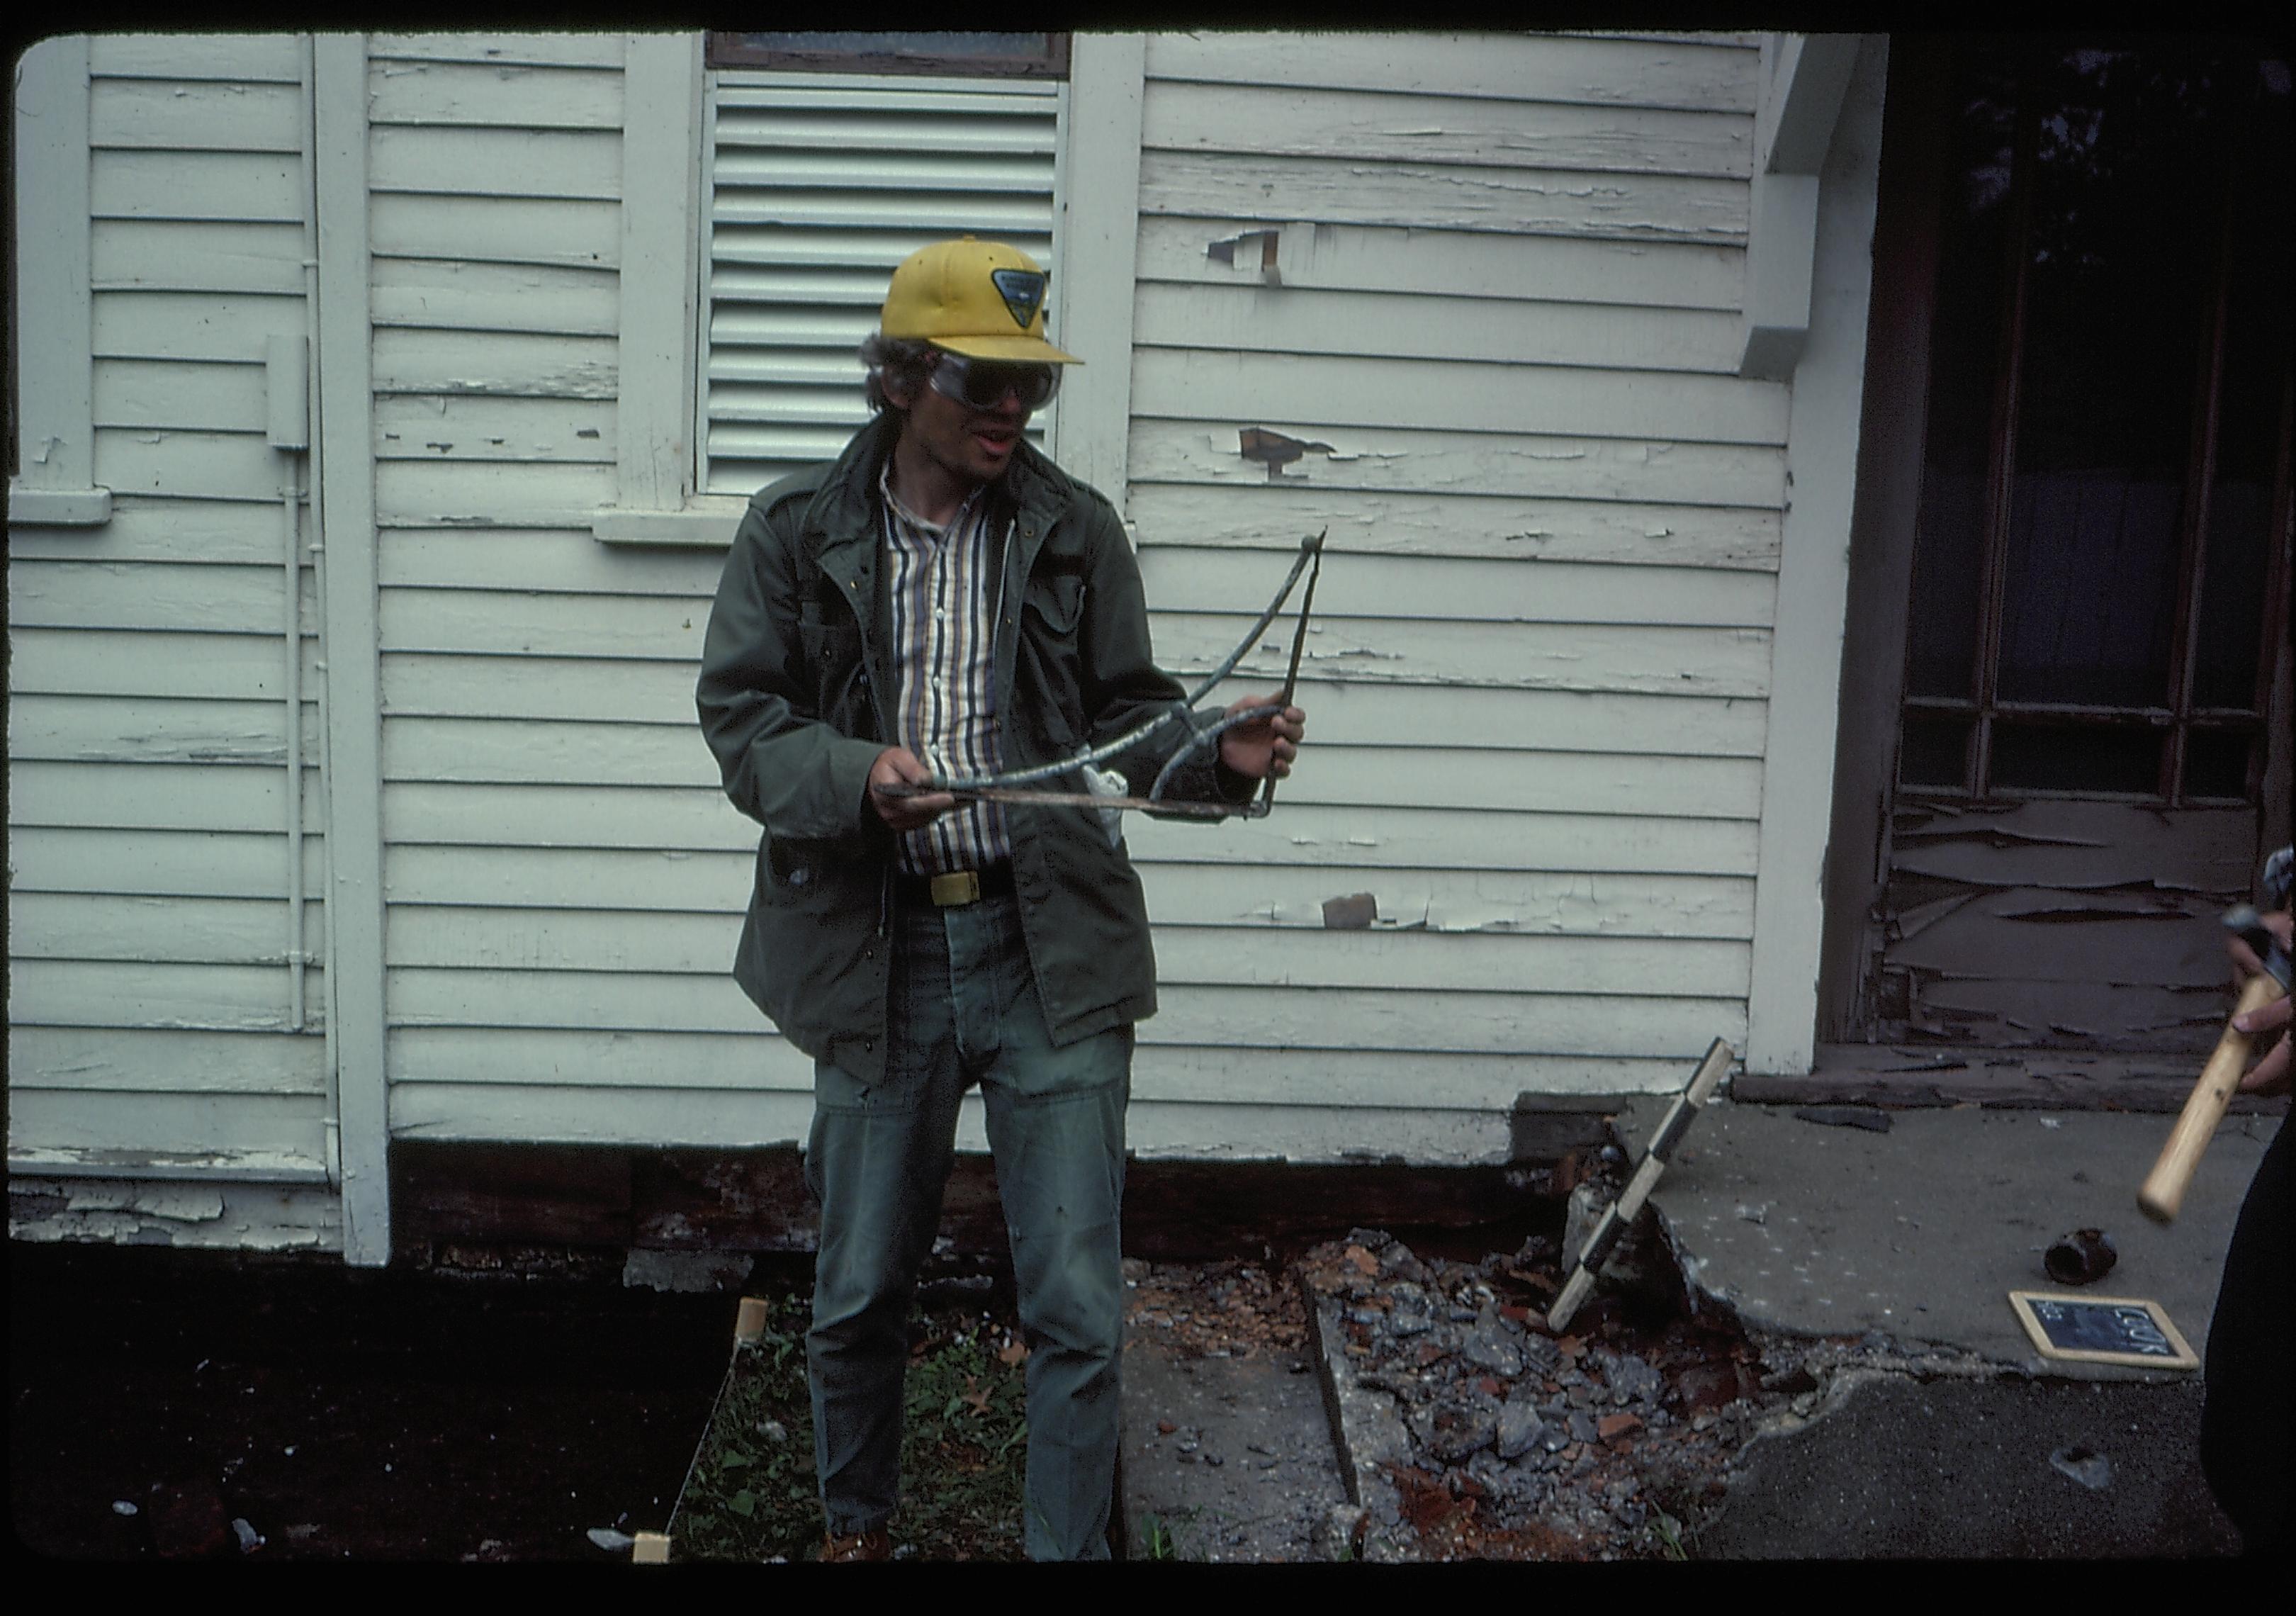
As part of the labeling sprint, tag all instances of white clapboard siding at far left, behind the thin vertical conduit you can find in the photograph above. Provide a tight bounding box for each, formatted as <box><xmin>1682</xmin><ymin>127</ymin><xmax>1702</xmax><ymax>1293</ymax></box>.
<box><xmin>9</xmin><ymin>35</ymin><xmax>331</xmax><ymax>1184</ymax></box>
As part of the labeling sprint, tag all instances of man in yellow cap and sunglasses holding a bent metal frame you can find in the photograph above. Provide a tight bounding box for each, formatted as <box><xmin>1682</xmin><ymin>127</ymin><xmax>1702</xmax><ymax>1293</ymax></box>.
<box><xmin>698</xmin><ymin>237</ymin><xmax>1307</xmax><ymax>1561</ymax></box>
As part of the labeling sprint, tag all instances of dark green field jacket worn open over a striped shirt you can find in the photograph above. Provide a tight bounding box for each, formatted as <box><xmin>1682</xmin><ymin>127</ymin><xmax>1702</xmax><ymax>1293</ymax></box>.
<box><xmin>696</xmin><ymin>413</ymin><xmax>1254</xmax><ymax>1084</ymax></box>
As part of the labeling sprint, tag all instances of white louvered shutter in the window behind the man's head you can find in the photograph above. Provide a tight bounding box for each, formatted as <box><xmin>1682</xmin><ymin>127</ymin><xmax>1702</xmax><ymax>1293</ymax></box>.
<box><xmin>700</xmin><ymin>74</ymin><xmax>1063</xmax><ymax>493</ymax></box>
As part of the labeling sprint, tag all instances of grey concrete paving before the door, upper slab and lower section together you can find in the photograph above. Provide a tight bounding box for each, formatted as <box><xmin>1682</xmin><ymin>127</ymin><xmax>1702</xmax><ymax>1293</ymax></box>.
<box><xmin>1616</xmin><ymin>1099</ymin><xmax>2280</xmax><ymax>1559</ymax></box>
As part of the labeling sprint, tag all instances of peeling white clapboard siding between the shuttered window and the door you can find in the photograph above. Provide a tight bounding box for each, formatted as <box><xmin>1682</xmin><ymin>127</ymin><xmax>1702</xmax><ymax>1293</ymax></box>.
<box><xmin>1102</xmin><ymin>32</ymin><xmax>1789</xmax><ymax>1157</ymax></box>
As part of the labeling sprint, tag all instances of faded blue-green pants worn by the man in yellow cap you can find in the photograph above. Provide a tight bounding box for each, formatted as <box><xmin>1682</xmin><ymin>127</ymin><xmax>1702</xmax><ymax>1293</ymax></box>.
<box><xmin>806</xmin><ymin>897</ymin><xmax>1132</xmax><ymax>1559</ymax></box>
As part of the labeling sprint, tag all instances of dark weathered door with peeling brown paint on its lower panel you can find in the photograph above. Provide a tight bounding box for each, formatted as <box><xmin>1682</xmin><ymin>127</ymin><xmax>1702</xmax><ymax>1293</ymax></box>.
<box><xmin>1859</xmin><ymin>37</ymin><xmax>2292</xmax><ymax>1049</ymax></box>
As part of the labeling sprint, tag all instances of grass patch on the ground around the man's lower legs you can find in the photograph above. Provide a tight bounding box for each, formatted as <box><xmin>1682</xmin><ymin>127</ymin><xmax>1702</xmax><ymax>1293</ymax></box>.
<box><xmin>670</xmin><ymin>1297</ymin><xmax>1029</xmax><ymax>1564</ymax></box>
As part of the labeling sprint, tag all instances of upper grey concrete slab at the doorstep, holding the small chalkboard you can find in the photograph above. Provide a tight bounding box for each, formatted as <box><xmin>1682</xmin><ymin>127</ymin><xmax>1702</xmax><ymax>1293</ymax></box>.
<box><xmin>1616</xmin><ymin>1097</ymin><xmax>2278</xmax><ymax>1379</ymax></box>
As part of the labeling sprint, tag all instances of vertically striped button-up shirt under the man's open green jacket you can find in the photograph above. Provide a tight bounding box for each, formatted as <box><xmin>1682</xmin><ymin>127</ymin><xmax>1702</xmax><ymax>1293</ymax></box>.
<box><xmin>877</xmin><ymin>468</ymin><xmax>1013</xmax><ymax>875</ymax></box>
